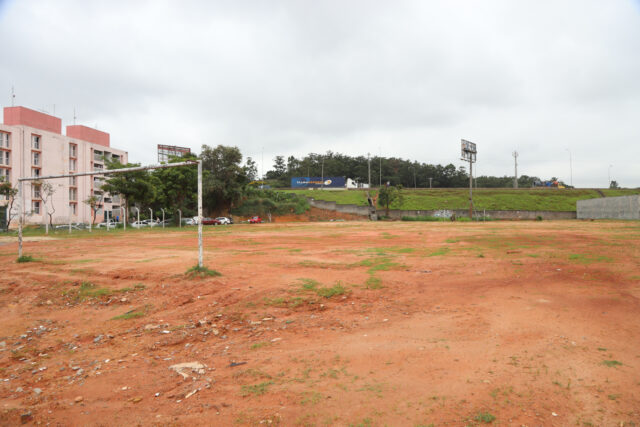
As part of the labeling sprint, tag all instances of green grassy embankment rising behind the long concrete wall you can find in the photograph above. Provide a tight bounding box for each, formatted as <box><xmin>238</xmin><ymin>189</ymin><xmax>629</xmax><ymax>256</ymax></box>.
<box><xmin>283</xmin><ymin>188</ymin><xmax>640</xmax><ymax>211</ymax></box>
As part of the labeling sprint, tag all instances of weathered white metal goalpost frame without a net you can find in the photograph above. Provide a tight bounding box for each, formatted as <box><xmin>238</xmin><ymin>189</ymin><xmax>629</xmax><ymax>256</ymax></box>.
<box><xmin>18</xmin><ymin>160</ymin><xmax>203</xmax><ymax>268</ymax></box>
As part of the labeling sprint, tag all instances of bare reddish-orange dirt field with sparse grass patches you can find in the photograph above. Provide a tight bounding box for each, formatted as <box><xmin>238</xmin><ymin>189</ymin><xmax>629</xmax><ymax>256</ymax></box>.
<box><xmin>0</xmin><ymin>221</ymin><xmax>640</xmax><ymax>426</ymax></box>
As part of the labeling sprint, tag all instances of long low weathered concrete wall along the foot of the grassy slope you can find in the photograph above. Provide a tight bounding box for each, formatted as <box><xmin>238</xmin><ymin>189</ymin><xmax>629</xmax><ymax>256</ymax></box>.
<box><xmin>309</xmin><ymin>198</ymin><xmax>576</xmax><ymax>220</ymax></box>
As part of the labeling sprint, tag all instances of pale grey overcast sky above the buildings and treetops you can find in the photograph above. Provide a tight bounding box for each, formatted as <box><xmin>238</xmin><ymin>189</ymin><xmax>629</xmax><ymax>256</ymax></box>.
<box><xmin>0</xmin><ymin>0</ymin><xmax>640</xmax><ymax>187</ymax></box>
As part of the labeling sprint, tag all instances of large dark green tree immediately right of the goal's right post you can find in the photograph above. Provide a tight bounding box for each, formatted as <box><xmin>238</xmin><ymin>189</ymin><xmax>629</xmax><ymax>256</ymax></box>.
<box><xmin>201</xmin><ymin>145</ymin><xmax>249</xmax><ymax>213</ymax></box>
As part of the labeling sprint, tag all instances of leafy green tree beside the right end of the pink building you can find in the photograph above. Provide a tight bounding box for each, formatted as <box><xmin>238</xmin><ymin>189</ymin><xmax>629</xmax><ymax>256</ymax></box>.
<box><xmin>102</xmin><ymin>159</ymin><xmax>159</xmax><ymax>221</ymax></box>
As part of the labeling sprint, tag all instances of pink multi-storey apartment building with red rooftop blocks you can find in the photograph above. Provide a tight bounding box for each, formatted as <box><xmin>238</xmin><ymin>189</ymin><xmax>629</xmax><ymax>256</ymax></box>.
<box><xmin>0</xmin><ymin>107</ymin><xmax>128</xmax><ymax>227</ymax></box>
